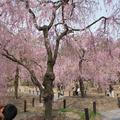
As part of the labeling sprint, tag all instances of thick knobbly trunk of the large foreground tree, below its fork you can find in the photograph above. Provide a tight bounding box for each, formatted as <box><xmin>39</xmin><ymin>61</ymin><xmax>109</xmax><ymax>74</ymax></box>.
<box><xmin>43</xmin><ymin>64</ymin><xmax>55</xmax><ymax>120</ymax></box>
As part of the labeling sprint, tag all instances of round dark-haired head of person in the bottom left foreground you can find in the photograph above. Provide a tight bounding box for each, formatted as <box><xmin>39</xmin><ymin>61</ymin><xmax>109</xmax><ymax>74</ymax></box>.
<box><xmin>2</xmin><ymin>104</ymin><xmax>17</xmax><ymax>120</ymax></box>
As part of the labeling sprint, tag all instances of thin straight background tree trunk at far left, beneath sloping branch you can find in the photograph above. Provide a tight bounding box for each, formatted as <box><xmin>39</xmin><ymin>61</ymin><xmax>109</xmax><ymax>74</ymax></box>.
<box><xmin>14</xmin><ymin>67</ymin><xmax>19</xmax><ymax>99</ymax></box>
